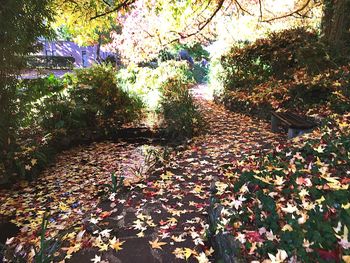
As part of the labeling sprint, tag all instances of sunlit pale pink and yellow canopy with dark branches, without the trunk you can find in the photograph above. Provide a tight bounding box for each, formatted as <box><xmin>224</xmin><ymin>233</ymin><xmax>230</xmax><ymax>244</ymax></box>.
<box><xmin>106</xmin><ymin>0</ymin><xmax>320</xmax><ymax>62</ymax></box>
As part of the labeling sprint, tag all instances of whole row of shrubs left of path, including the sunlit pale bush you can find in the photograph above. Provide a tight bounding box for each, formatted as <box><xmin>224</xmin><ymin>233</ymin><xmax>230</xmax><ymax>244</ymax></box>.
<box><xmin>1</xmin><ymin>61</ymin><xmax>200</xmax><ymax>184</ymax></box>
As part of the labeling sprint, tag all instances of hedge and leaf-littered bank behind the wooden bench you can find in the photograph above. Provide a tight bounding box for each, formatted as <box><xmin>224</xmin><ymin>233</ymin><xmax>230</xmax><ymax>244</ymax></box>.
<box><xmin>213</xmin><ymin>28</ymin><xmax>350</xmax><ymax>117</ymax></box>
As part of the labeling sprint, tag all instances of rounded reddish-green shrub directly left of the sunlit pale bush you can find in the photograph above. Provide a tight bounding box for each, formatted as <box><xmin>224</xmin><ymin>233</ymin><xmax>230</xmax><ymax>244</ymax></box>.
<box><xmin>71</xmin><ymin>65</ymin><xmax>143</xmax><ymax>129</ymax></box>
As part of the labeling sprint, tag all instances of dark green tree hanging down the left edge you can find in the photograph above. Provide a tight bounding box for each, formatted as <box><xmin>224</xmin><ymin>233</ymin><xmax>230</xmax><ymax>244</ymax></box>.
<box><xmin>0</xmin><ymin>0</ymin><xmax>53</xmax><ymax>180</ymax></box>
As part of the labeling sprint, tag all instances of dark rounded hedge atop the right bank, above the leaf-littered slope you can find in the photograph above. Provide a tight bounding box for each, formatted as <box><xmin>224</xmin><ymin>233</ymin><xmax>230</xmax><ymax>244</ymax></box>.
<box><xmin>221</xmin><ymin>28</ymin><xmax>334</xmax><ymax>90</ymax></box>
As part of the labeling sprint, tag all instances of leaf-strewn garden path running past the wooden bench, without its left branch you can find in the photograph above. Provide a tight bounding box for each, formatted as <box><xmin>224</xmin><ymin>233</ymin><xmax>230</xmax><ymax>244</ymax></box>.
<box><xmin>67</xmin><ymin>85</ymin><xmax>282</xmax><ymax>262</ymax></box>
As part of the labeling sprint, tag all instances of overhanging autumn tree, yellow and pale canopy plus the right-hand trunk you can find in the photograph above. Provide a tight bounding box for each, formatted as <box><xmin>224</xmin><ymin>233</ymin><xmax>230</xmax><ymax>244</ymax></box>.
<box><xmin>55</xmin><ymin>0</ymin><xmax>350</xmax><ymax>58</ymax></box>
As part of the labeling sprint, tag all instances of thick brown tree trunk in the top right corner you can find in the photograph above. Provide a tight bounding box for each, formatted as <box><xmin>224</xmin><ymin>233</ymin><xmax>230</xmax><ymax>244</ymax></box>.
<box><xmin>322</xmin><ymin>0</ymin><xmax>350</xmax><ymax>53</ymax></box>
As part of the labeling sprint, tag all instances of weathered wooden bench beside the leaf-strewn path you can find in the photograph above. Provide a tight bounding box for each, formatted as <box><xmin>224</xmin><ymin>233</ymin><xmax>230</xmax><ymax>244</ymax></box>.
<box><xmin>271</xmin><ymin>111</ymin><xmax>317</xmax><ymax>139</ymax></box>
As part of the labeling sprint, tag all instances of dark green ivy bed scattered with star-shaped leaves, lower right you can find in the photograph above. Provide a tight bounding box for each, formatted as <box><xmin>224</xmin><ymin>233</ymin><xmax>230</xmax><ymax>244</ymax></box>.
<box><xmin>216</xmin><ymin>114</ymin><xmax>350</xmax><ymax>262</ymax></box>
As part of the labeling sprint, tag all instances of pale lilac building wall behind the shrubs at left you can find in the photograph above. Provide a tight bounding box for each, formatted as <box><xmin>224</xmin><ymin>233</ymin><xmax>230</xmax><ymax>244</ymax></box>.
<box><xmin>37</xmin><ymin>41</ymin><xmax>113</xmax><ymax>68</ymax></box>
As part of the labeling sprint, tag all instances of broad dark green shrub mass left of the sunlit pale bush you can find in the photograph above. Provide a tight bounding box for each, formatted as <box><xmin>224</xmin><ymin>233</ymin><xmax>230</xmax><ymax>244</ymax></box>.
<box><xmin>0</xmin><ymin>66</ymin><xmax>143</xmax><ymax>183</ymax></box>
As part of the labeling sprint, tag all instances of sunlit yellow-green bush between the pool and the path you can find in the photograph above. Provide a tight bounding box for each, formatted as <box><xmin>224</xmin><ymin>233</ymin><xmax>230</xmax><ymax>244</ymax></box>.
<box><xmin>118</xmin><ymin>60</ymin><xmax>201</xmax><ymax>139</ymax></box>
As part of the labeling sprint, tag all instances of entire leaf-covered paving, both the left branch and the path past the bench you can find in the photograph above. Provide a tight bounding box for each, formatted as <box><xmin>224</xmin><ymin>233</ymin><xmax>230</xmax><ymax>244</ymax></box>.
<box><xmin>0</xmin><ymin>85</ymin><xmax>283</xmax><ymax>262</ymax></box>
